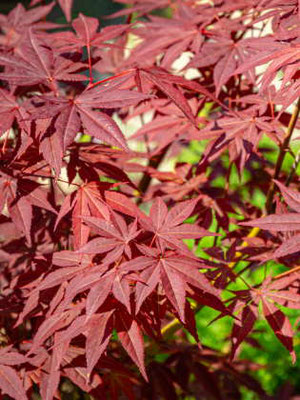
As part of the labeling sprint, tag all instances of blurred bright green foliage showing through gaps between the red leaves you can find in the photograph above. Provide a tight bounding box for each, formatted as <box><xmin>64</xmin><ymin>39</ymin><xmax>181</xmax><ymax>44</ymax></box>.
<box><xmin>179</xmin><ymin>136</ymin><xmax>300</xmax><ymax>400</ymax></box>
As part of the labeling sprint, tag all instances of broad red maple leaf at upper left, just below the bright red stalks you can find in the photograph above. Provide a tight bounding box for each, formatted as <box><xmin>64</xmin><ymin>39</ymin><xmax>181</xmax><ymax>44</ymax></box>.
<box><xmin>31</xmin><ymin>85</ymin><xmax>149</xmax><ymax>160</ymax></box>
